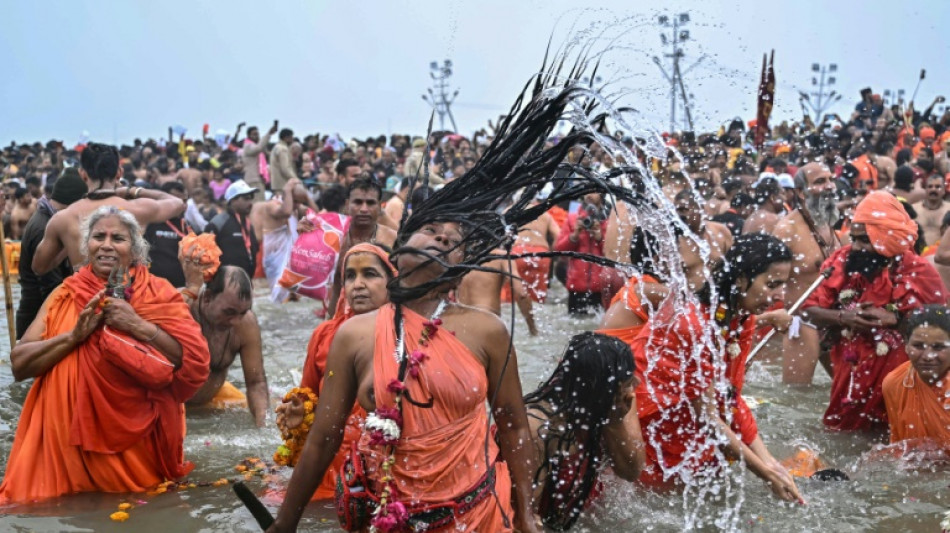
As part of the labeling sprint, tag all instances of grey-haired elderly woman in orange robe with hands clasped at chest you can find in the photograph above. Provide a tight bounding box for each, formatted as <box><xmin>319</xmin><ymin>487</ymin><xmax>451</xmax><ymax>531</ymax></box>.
<box><xmin>0</xmin><ymin>206</ymin><xmax>210</xmax><ymax>503</ymax></box>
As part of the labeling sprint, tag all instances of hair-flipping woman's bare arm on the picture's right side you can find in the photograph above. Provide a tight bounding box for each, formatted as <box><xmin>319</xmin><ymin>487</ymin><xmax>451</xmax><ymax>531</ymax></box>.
<box><xmin>485</xmin><ymin>315</ymin><xmax>540</xmax><ymax>532</ymax></box>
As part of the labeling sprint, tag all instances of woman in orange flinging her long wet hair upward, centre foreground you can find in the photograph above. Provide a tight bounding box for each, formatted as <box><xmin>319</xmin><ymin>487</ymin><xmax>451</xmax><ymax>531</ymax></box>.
<box><xmin>269</xmin><ymin>47</ymin><xmax>660</xmax><ymax>533</ymax></box>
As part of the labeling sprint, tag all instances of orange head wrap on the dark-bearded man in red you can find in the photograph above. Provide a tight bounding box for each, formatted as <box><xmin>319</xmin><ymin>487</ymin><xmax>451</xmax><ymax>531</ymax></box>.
<box><xmin>853</xmin><ymin>191</ymin><xmax>917</xmax><ymax>257</ymax></box>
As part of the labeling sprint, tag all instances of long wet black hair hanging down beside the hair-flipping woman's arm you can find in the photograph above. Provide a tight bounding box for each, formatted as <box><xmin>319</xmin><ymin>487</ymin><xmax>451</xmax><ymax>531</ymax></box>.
<box><xmin>524</xmin><ymin>331</ymin><xmax>636</xmax><ymax>531</ymax></box>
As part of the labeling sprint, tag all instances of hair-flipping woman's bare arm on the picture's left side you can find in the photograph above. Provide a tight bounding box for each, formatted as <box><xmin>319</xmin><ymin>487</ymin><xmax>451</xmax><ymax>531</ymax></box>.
<box><xmin>267</xmin><ymin>315</ymin><xmax>362</xmax><ymax>533</ymax></box>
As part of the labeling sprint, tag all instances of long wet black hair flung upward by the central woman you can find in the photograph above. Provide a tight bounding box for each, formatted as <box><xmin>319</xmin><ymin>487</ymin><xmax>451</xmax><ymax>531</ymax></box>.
<box><xmin>389</xmin><ymin>53</ymin><xmax>648</xmax><ymax>304</ymax></box>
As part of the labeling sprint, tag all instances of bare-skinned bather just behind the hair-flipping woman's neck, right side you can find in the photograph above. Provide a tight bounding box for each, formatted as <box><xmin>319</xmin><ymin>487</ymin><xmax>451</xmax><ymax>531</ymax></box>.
<box><xmin>456</xmin><ymin>250</ymin><xmax>538</xmax><ymax>337</ymax></box>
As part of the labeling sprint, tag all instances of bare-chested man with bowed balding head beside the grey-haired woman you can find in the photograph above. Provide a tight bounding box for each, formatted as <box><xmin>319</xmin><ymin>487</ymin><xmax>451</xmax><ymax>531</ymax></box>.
<box><xmin>181</xmin><ymin>260</ymin><xmax>270</xmax><ymax>427</ymax></box>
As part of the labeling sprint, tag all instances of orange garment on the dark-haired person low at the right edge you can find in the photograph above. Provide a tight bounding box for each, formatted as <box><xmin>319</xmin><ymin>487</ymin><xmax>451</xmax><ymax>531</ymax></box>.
<box><xmin>882</xmin><ymin>361</ymin><xmax>950</xmax><ymax>449</ymax></box>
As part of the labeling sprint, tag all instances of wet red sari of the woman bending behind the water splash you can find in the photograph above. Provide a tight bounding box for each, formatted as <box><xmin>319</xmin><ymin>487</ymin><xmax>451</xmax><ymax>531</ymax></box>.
<box><xmin>631</xmin><ymin>302</ymin><xmax>758</xmax><ymax>484</ymax></box>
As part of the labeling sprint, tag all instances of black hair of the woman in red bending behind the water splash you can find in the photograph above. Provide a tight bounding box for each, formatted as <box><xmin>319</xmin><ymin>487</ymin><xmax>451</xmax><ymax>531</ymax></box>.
<box><xmin>700</xmin><ymin>233</ymin><xmax>792</xmax><ymax>325</ymax></box>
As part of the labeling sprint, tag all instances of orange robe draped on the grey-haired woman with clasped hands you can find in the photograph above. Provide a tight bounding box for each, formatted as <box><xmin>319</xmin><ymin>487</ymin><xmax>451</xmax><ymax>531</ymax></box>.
<box><xmin>0</xmin><ymin>266</ymin><xmax>210</xmax><ymax>503</ymax></box>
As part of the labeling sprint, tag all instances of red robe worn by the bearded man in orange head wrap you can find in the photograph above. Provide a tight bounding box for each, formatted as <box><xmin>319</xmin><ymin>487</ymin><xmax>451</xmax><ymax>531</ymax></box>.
<box><xmin>803</xmin><ymin>245</ymin><xmax>947</xmax><ymax>430</ymax></box>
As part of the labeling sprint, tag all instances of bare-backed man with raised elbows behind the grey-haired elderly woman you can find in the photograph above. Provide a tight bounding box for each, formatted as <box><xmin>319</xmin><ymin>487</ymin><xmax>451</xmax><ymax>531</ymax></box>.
<box><xmin>33</xmin><ymin>143</ymin><xmax>185</xmax><ymax>274</ymax></box>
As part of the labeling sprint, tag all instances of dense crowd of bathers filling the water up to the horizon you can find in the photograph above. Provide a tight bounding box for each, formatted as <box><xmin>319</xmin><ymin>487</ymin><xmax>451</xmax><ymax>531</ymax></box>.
<box><xmin>0</xmin><ymin>80</ymin><xmax>950</xmax><ymax>531</ymax></box>
